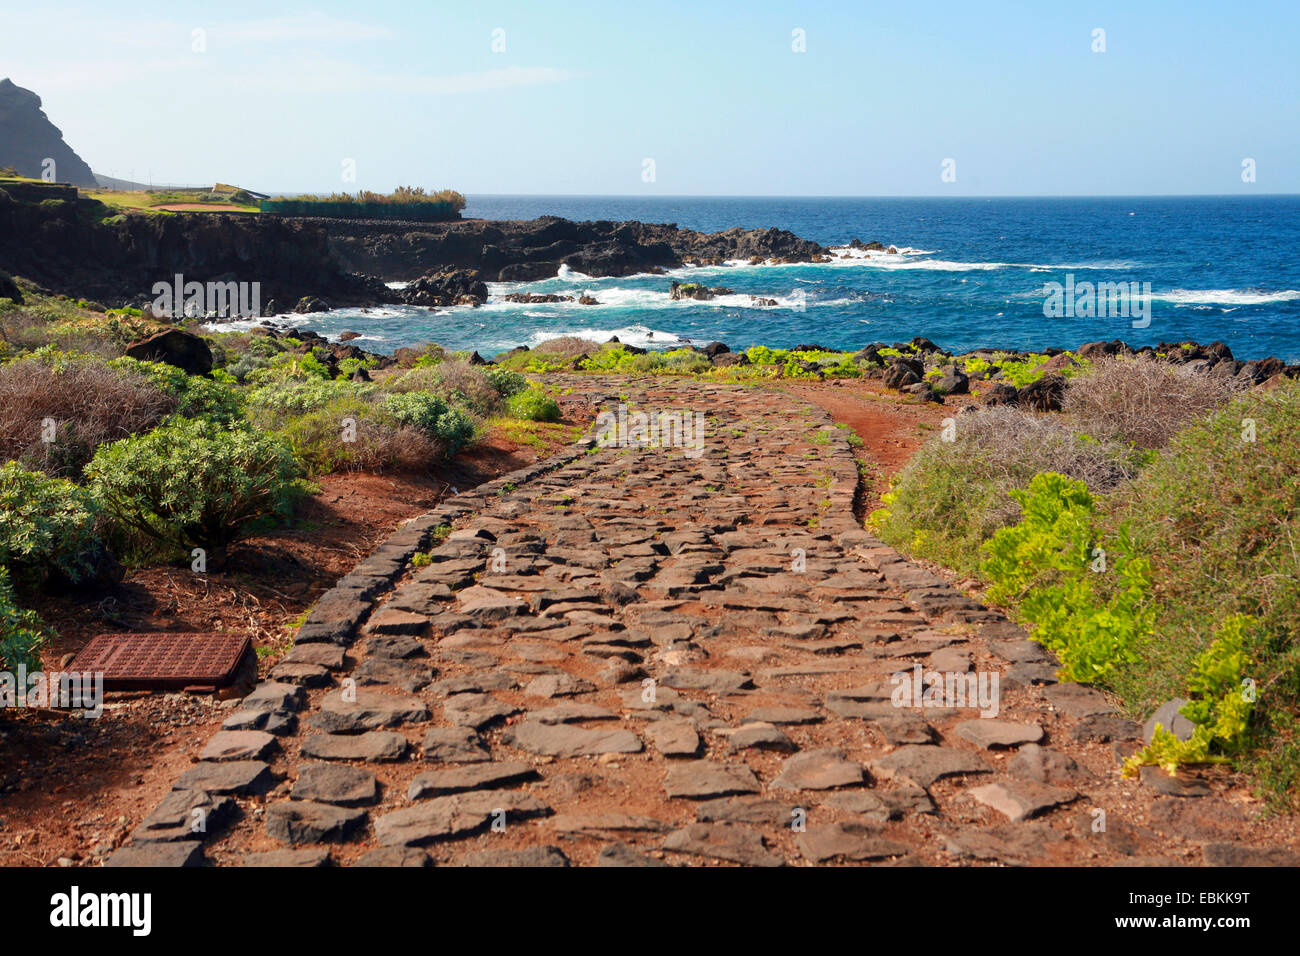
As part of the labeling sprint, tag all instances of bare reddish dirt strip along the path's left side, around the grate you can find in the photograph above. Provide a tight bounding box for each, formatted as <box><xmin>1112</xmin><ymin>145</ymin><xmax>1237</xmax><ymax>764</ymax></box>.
<box><xmin>0</xmin><ymin>421</ymin><xmax>589</xmax><ymax>866</ymax></box>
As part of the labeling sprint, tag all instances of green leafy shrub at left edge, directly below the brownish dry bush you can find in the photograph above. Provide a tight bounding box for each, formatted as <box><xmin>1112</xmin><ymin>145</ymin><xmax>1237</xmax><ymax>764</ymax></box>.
<box><xmin>0</xmin><ymin>462</ymin><xmax>99</xmax><ymax>584</ymax></box>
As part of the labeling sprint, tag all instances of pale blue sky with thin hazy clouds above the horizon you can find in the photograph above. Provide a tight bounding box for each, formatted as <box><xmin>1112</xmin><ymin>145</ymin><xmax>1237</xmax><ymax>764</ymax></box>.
<box><xmin>0</xmin><ymin>0</ymin><xmax>1300</xmax><ymax>196</ymax></box>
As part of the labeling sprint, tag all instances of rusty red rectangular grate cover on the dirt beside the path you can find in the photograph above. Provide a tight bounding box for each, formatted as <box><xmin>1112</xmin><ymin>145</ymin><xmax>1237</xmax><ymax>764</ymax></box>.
<box><xmin>68</xmin><ymin>631</ymin><xmax>252</xmax><ymax>691</ymax></box>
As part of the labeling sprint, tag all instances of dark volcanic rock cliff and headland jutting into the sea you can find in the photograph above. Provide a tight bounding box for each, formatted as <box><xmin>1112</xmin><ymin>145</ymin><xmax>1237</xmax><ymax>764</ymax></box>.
<box><xmin>0</xmin><ymin>192</ymin><xmax>824</xmax><ymax>310</ymax></box>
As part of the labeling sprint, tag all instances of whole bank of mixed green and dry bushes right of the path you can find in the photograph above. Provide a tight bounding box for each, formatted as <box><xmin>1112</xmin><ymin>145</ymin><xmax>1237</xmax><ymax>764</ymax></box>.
<box><xmin>868</xmin><ymin>358</ymin><xmax>1300</xmax><ymax>809</ymax></box>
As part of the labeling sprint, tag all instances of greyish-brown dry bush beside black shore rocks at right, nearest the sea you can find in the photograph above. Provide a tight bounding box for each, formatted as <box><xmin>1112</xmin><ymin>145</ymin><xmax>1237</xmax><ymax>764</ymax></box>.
<box><xmin>1063</xmin><ymin>358</ymin><xmax>1240</xmax><ymax>449</ymax></box>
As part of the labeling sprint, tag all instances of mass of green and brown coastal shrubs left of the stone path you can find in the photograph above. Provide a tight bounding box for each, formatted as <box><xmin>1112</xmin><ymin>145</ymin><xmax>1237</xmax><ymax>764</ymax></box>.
<box><xmin>0</xmin><ymin>278</ymin><xmax>566</xmax><ymax>669</ymax></box>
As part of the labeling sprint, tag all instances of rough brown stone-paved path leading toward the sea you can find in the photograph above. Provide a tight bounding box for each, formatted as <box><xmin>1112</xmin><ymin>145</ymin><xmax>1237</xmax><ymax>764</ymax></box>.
<box><xmin>109</xmin><ymin>377</ymin><xmax>1295</xmax><ymax>866</ymax></box>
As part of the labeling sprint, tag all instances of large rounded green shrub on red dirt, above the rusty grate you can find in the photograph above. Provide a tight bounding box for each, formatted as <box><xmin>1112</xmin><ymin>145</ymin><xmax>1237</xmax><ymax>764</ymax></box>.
<box><xmin>86</xmin><ymin>418</ymin><xmax>303</xmax><ymax>551</ymax></box>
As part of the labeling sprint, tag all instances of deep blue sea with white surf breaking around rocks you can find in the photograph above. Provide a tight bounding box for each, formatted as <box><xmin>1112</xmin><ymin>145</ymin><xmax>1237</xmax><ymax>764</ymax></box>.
<box><xmin>231</xmin><ymin>195</ymin><xmax>1300</xmax><ymax>363</ymax></box>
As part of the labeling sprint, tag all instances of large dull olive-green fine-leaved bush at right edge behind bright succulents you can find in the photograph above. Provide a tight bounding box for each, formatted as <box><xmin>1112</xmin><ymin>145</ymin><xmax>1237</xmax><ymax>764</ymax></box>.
<box><xmin>1102</xmin><ymin>382</ymin><xmax>1300</xmax><ymax>805</ymax></box>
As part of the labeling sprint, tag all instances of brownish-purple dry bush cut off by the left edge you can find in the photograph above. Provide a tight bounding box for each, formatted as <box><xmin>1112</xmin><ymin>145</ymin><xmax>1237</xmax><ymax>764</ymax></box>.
<box><xmin>0</xmin><ymin>358</ymin><xmax>177</xmax><ymax>479</ymax></box>
